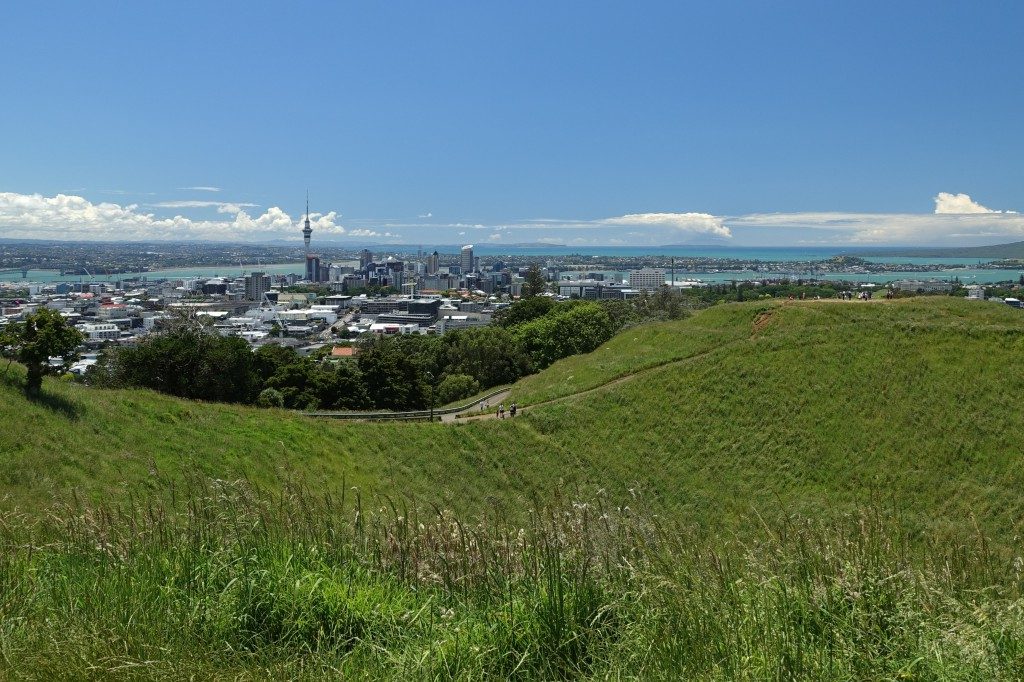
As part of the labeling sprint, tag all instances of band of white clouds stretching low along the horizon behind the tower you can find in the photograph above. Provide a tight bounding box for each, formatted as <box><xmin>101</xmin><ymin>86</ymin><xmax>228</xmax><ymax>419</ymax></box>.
<box><xmin>0</xmin><ymin>186</ymin><xmax>1024</xmax><ymax>246</ymax></box>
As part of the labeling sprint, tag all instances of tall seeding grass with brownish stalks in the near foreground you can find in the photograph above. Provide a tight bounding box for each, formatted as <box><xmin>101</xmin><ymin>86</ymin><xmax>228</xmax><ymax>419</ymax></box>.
<box><xmin>0</xmin><ymin>479</ymin><xmax>1024</xmax><ymax>680</ymax></box>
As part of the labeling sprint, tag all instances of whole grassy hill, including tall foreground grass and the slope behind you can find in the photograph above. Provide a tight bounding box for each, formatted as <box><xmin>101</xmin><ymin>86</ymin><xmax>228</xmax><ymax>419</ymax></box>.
<box><xmin>0</xmin><ymin>298</ymin><xmax>1024</xmax><ymax>680</ymax></box>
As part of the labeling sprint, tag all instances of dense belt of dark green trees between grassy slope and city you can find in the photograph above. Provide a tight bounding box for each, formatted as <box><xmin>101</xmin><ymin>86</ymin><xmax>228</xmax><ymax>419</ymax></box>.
<box><xmin>86</xmin><ymin>297</ymin><xmax>618</xmax><ymax>410</ymax></box>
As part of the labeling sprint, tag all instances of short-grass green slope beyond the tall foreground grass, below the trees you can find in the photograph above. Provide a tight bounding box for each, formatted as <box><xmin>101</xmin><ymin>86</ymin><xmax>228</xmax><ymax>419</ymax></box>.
<box><xmin>6</xmin><ymin>298</ymin><xmax>1024</xmax><ymax>543</ymax></box>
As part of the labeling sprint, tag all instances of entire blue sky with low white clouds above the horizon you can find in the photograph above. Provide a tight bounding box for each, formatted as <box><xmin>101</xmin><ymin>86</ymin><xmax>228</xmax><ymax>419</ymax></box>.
<box><xmin>0</xmin><ymin>2</ymin><xmax>1024</xmax><ymax>246</ymax></box>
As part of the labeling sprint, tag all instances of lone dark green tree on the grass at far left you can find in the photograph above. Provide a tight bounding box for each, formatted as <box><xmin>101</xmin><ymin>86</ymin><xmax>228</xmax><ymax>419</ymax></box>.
<box><xmin>0</xmin><ymin>308</ymin><xmax>83</xmax><ymax>395</ymax></box>
